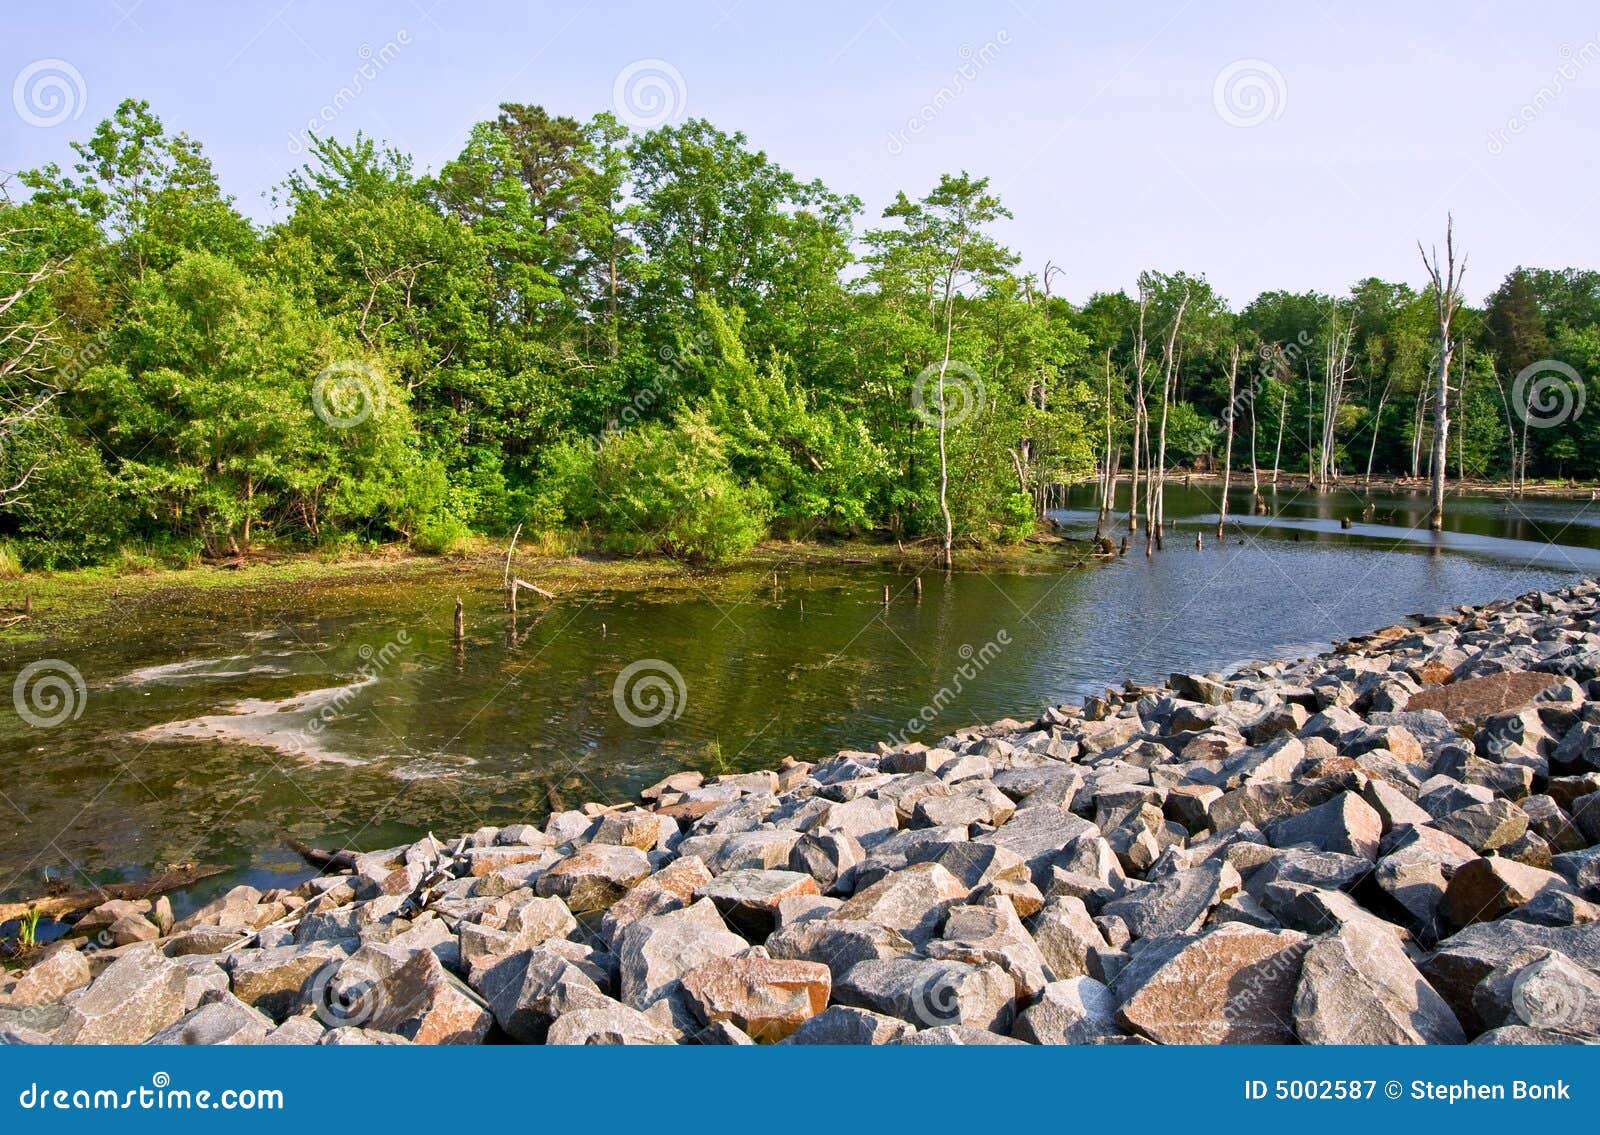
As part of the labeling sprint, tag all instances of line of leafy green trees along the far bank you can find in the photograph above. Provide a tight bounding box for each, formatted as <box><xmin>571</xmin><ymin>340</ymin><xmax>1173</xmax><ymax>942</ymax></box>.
<box><xmin>0</xmin><ymin>101</ymin><xmax>1600</xmax><ymax>568</ymax></box>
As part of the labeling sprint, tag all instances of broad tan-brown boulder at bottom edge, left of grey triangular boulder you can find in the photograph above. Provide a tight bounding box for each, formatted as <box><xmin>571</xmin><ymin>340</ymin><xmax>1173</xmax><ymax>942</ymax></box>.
<box><xmin>1112</xmin><ymin>922</ymin><xmax>1306</xmax><ymax>1044</ymax></box>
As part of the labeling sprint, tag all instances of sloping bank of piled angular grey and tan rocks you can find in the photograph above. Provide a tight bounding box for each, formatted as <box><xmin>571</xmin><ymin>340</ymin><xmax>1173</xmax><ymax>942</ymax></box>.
<box><xmin>0</xmin><ymin>581</ymin><xmax>1600</xmax><ymax>1044</ymax></box>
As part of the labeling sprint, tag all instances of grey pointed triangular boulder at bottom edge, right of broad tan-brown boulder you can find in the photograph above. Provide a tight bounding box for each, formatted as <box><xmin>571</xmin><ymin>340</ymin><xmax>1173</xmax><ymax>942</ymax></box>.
<box><xmin>1294</xmin><ymin>919</ymin><xmax>1467</xmax><ymax>1044</ymax></box>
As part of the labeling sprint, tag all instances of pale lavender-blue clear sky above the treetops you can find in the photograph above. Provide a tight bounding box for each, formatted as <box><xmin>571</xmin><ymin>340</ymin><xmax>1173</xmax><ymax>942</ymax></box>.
<box><xmin>0</xmin><ymin>0</ymin><xmax>1600</xmax><ymax>304</ymax></box>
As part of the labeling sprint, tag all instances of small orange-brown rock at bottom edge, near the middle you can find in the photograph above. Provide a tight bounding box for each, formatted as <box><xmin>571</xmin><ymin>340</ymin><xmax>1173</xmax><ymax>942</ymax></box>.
<box><xmin>683</xmin><ymin>956</ymin><xmax>832</xmax><ymax>1044</ymax></box>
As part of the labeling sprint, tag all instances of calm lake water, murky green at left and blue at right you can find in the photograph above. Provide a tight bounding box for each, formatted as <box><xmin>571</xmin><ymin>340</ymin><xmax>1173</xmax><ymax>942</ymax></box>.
<box><xmin>0</xmin><ymin>483</ymin><xmax>1600</xmax><ymax>898</ymax></box>
